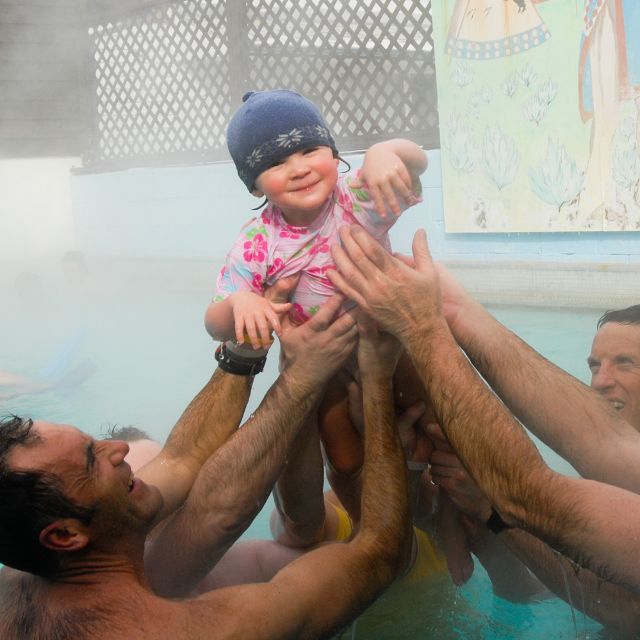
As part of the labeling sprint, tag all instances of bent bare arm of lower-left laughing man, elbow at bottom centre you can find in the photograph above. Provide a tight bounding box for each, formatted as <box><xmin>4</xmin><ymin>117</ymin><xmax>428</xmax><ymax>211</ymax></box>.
<box><xmin>182</xmin><ymin>316</ymin><xmax>411</xmax><ymax>639</ymax></box>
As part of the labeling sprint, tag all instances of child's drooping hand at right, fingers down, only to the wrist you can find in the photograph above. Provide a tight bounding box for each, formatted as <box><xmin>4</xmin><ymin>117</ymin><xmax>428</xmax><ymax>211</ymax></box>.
<box><xmin>352</xmin><ymin>144</ymin><xmax>414</xmax><ymax>218</ymax></box>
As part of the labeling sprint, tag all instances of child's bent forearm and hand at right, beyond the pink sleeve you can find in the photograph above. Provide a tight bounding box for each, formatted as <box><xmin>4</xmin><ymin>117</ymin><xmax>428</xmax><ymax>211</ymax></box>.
<box><xmin>353</xmin><ymin>138</ymin><xmax>427</xmax><ymax>217</ymax></box>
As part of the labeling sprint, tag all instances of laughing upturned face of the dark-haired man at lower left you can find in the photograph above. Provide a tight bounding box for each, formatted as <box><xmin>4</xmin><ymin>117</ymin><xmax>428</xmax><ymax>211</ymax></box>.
<box><xmin>9</xmin><ymin>420</ymin><xmax>162</xmax><ymax>533</ymax></box>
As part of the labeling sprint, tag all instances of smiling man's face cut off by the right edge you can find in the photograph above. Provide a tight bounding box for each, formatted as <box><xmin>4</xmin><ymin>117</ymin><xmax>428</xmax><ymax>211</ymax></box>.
<box><xmin>587</xmin><ymin>322</ymin><xmax>640</xmax><ymax>431</ymax></box>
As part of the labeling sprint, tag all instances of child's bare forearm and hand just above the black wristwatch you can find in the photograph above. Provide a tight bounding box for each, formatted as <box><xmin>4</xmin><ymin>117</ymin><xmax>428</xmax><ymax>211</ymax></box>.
<box><xmin>204</xmin><ymin>291</ymin><xmax>291</xmax><ymax>349</ymax></box>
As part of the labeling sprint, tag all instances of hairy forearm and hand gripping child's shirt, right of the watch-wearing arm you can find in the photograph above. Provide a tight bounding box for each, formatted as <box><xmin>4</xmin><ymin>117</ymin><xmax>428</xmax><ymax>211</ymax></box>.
<box><xmin>145</xmin><ymin>296</ymin><xmax>357</xmax><ymax>596</ymax></box>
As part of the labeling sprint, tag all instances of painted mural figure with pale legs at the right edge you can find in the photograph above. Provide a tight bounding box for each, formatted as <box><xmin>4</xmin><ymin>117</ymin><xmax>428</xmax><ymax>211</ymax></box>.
<box><xmin>578</xmin><ymin>0</ymin><xmax>640</xmax><ymax>224</ymax></box>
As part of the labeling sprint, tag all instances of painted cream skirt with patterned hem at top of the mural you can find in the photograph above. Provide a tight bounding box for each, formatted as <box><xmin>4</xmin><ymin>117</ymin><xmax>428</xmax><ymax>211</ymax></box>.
<box><xmin>446</xmin><ymin>0</ymin><xmax>549</xmax><ymax>60</ymax></box>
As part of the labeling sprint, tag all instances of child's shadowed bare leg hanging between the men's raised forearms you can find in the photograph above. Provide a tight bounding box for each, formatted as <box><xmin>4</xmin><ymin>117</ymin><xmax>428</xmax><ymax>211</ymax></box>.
<box><xmin>318</xmin><ymin>378</ymin><xmax>364</xmax><ymax>526</ymax></box>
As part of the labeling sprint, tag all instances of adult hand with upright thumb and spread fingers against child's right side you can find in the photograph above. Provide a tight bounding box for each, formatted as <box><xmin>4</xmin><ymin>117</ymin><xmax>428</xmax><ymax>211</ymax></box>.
<box><xmin>328</xmin><ymin>225</ymin><xmax>444</xmax><ymax>339</ymax></box>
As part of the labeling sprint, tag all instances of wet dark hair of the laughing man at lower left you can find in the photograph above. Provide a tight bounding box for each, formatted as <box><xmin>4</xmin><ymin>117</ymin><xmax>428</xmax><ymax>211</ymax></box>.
<box><xmin>0</xmin><ymin>415</ymin><xmax>94</xmax><ymax>577</ymax></box>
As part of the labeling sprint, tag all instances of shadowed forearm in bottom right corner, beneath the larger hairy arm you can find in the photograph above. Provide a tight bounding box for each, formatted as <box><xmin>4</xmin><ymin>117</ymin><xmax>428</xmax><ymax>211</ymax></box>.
<box><xmin>500</xmin><ymin>529</ymin><xmax>640</xmax><ymax>640</ymax></box>
